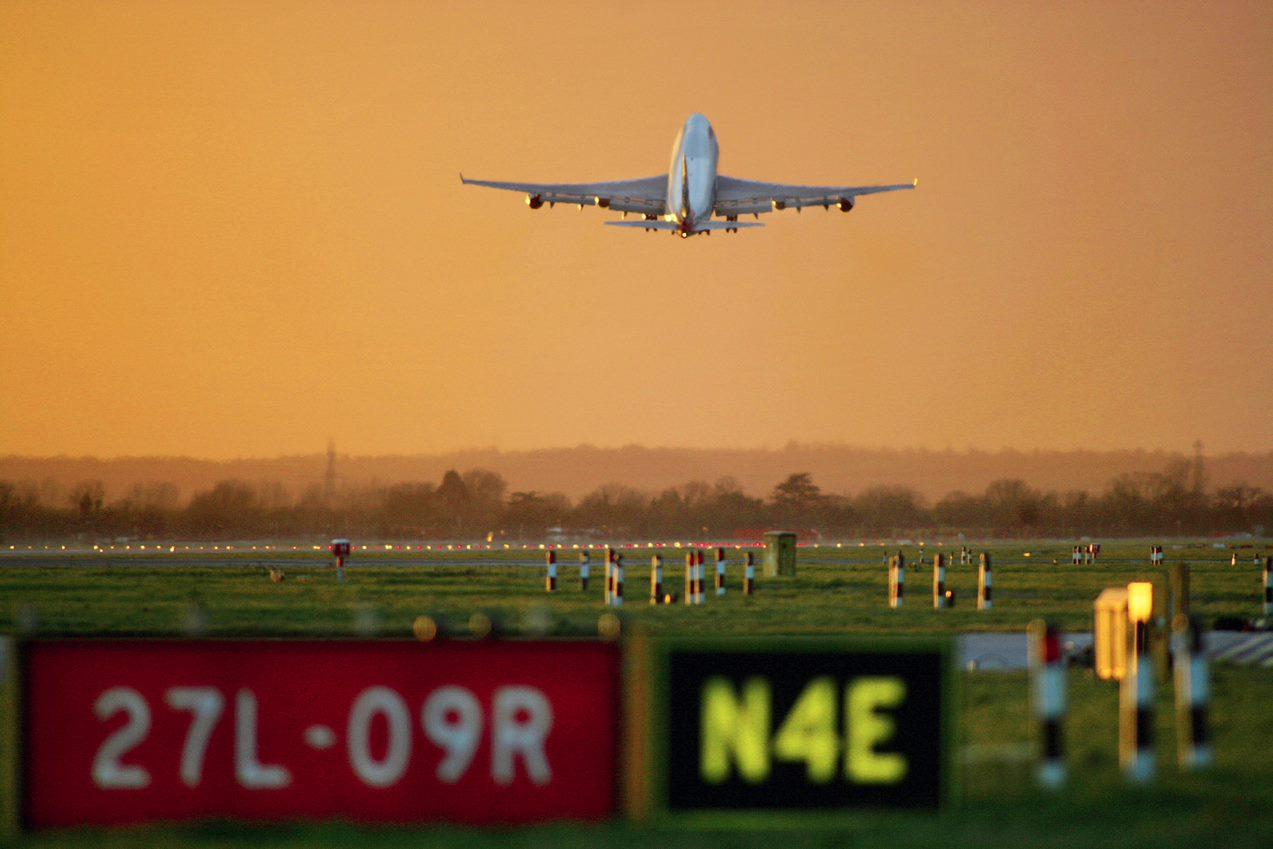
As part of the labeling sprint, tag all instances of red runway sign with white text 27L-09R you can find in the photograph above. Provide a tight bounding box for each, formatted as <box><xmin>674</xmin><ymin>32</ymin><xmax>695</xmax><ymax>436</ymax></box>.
<box><xmin>23</xmin><ymin>640</ymin><xmax>620</xmax><ymax>827</ymax></box>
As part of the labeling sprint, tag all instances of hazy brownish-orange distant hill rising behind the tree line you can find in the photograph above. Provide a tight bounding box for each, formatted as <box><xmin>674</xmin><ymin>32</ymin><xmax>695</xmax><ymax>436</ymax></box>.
<box><xmin>0</xmin><ymin>443</ymin><xmax>1273</xmax><ymax>502</ymax></box>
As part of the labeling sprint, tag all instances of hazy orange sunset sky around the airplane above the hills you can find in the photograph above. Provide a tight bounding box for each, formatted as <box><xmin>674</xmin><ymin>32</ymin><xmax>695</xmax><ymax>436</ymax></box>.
<box><xmin>0</xmin><ymin>0</ymin><xmax>1273</xmax><ymax>457</ymax></box>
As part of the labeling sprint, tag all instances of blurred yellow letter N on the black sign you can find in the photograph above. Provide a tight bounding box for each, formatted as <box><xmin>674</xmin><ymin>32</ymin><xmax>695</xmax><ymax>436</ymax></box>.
<box><xmin>699</xmin><ymin>677</ymin><xmax>771</xmax><ymax>784</ymax></box>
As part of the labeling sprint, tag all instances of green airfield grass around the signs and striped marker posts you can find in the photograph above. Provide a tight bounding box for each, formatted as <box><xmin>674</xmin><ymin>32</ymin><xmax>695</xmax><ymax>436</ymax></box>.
<box><xmin>0</xmin><ymin>542</ymin><xmax>1273</xmax><ymax>849</ymax></box>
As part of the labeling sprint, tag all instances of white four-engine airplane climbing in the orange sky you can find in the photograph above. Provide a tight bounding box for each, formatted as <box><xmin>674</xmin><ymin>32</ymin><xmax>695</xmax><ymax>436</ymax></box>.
<box><xmin>460</xmin><ymin>115</ymin><xmax>919</xmax><ymax>239</ymax></box>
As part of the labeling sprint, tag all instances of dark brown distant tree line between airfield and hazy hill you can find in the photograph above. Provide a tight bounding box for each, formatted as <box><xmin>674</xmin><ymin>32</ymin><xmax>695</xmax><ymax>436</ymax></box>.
<box><xmin>0</xmin><ymin>461</ymin><xmax>1273</xmax><ymax>544</ymax></box>
